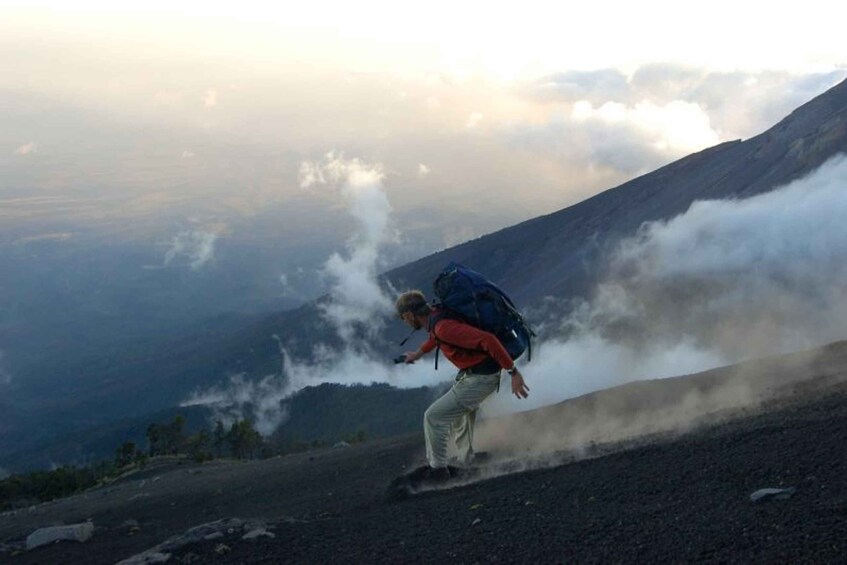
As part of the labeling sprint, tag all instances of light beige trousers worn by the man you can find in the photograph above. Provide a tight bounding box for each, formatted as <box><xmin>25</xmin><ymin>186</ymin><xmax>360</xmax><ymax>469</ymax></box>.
<box><xmin>424</xmin><ymin>371</ymin><xmax>500</xmax><ymax>467</ymax></box>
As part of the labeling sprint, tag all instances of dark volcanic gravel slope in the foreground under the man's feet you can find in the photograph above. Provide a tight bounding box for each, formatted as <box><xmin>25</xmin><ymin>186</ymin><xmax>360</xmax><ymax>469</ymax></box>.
<box><xmin>0</xmin><ymin>350</ymin><xmax>847</xmax><ymax>564</ymax></box>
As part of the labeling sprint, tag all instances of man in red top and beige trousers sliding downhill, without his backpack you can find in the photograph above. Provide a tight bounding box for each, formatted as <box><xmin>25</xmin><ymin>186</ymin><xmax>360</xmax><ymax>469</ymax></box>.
<box><xmin>395</xmin><ymin>290</ymin><xmax>529</xmax><ymax>480</ymax></box>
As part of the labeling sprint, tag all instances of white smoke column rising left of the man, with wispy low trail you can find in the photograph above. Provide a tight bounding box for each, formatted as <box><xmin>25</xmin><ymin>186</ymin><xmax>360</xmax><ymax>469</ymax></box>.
<box><xmin>184</xmin><ymin>153</ymin><xmax>449</xmax><ymax>435</ymax></box>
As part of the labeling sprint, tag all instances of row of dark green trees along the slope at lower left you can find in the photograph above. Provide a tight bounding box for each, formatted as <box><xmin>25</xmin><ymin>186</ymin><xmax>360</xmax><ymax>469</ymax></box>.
<box><xmin>0</xmin><ymin>415</ymin><xmax>366</xmax><ymax>511</ymax></box>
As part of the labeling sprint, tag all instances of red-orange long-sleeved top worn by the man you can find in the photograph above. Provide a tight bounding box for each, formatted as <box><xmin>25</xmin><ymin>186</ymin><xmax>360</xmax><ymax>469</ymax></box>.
<box><xmin>421</xmin><ymin>318</ymin><xmax>515</xmax><ymax>369</ymax></box>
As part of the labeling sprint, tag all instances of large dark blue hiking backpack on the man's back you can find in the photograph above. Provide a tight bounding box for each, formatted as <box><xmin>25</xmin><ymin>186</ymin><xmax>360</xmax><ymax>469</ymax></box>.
<box><xmin>433</xmin><ymin>261</ymin><xmax>535</xmax><ymax>369</ymax></box>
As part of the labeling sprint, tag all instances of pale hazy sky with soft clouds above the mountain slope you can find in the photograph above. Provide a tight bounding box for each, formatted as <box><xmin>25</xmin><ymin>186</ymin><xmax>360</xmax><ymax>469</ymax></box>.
<box><xmin>0</xmin><ymin>0</ymin><xmax>847</xmax><ymax>251</ymax></box>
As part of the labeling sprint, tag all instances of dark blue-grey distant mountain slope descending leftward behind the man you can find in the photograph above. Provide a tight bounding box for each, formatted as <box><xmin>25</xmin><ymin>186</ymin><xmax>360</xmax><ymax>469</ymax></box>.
<box><xmin>6</xmin><ymin>81</ymin><xmax>847</xmax><ymax>465</ymax></box>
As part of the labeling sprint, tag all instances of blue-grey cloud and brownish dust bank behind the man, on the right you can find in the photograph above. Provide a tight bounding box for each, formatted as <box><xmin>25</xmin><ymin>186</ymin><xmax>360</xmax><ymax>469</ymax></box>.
<box><xmin>487</xmin><ymin>156</ymin><xmax>847</xmax><ymax>414</ymax></box>
